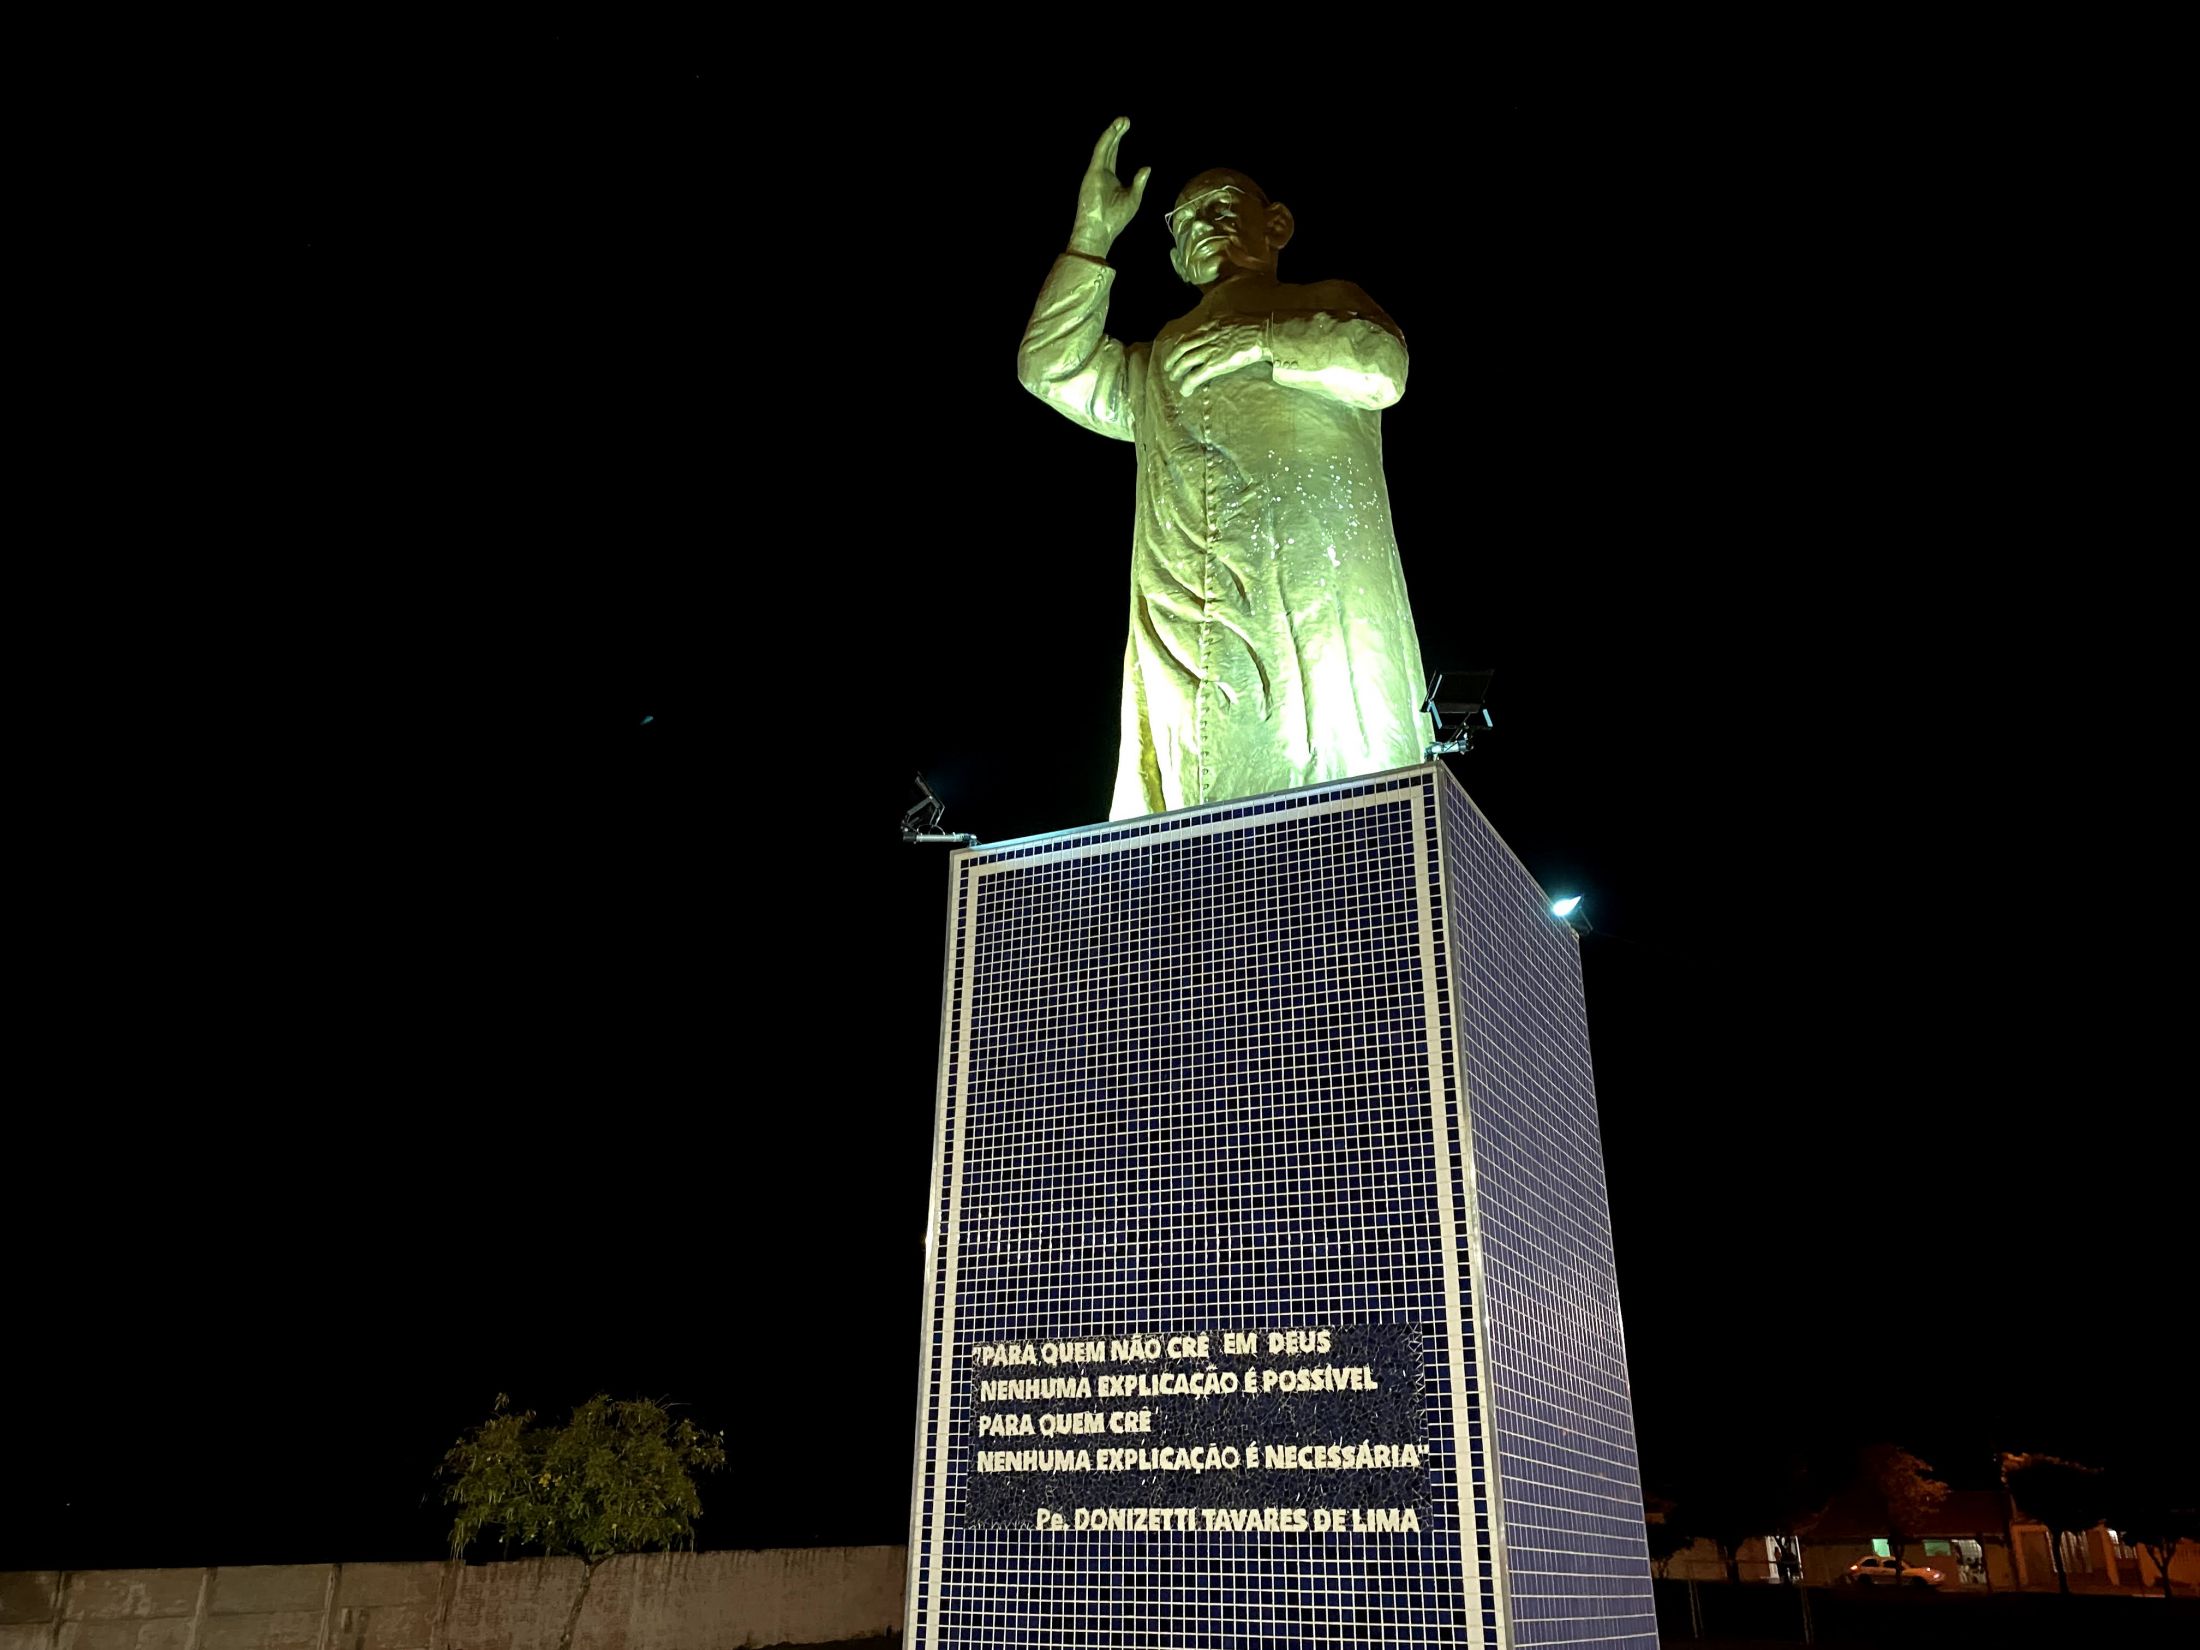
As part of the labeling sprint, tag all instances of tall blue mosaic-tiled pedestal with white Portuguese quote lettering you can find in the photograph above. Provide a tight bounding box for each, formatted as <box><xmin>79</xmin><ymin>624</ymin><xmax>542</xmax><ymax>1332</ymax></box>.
<box><xmin>906</xmin><ymin>763</ymin><xmax>1657</xmax><ymax>1650</ymax></box>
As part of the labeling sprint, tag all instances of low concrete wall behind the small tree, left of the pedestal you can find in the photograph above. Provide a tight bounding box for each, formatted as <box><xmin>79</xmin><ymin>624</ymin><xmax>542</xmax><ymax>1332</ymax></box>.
<box><xmin>0</xmin><ymin>1547</ymin><xmax>904</xmax><ymax>1650</ymax></box>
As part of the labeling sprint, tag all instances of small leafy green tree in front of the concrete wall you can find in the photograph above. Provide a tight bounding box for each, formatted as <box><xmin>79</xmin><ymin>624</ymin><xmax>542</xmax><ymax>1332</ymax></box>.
<box><xmin>442</xmin><ymin>1393</ymin><xmax>726</xmax><ymax>1650</ymax></box>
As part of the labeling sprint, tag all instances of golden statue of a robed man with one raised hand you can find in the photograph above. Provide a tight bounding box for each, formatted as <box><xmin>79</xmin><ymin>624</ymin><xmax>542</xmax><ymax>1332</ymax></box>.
<box><xmin>1016</xmin><ymin>119</ymin><xmax>1432</xmax><ymax>818</ymax></box>
